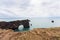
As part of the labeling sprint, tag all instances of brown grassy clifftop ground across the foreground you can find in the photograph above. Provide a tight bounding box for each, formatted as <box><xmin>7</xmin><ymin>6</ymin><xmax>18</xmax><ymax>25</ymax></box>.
<box><xmin>0</xmin><ymin>28</ymin><xmax>60</xmax><ymax>40</ymax></box>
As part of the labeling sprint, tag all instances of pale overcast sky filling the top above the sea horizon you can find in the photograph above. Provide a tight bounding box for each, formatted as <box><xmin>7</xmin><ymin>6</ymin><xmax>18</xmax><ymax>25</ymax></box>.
<box><xmin>0</xmin><ymin>0</ymin><xmax>60</xmax><ymax>18</ymax></box>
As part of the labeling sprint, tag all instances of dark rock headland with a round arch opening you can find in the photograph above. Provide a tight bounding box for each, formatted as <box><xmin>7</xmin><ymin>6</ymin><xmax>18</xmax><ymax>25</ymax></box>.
<box><xmin>0</xmin><ymin>19</ymin><xmax>30</xmax><ymax>30</ymax></box>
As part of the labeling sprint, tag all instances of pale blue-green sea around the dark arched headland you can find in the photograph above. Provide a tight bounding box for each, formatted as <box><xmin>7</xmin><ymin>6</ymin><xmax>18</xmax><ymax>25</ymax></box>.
<box><xmin>2</xmin><ymin>17</ymin><xmax>60</xmax><ymax>31</ymax></box>
